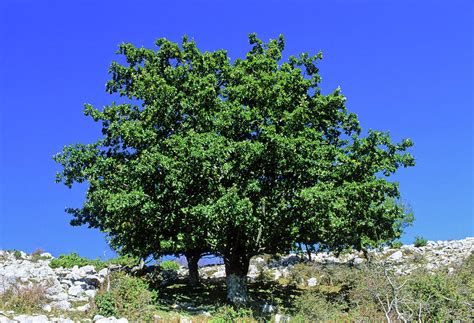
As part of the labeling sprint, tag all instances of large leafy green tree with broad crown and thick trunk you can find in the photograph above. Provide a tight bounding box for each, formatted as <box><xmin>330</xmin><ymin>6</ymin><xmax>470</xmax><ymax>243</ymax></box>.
<box><xmin>55</xmin><ymin>34</ymin><xmax>414</xmax><ymax>304</ymax></box>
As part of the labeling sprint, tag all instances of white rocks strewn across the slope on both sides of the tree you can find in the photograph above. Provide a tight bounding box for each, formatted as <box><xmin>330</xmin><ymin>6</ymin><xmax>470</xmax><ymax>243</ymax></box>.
<box><xmin>0</xmin><ymin>238</ymin><xmax>474</xmax><ymax>323</ymax></box>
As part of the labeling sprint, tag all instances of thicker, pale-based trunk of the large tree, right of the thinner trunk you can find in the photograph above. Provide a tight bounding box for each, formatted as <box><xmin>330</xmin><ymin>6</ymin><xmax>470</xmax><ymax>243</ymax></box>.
<box><xmin>224</xmin><ymin>252</ymin><xmax>250</xmax><ymax>306</ymax></box>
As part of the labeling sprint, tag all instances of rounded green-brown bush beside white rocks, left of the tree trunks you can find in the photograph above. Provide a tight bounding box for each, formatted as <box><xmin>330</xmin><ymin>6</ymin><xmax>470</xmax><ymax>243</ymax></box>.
<box><xmin>95</xmin><ymin>273</ymin><xmax>158</xmax><ymax>321</ymax></box>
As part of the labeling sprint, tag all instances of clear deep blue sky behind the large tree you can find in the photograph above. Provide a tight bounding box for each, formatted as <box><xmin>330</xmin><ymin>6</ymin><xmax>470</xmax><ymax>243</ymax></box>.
<box><xmin>0</xmin><ymin>0</ymin><xmax>474</xmax><ymax>257</ymax></box>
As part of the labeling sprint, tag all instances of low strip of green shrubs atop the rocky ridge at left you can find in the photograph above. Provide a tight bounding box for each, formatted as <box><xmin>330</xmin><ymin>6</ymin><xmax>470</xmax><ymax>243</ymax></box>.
<box><xmin>49</xmin><ymin>252</ymin><xmax>138</xmax><ymax>270</ymax></box>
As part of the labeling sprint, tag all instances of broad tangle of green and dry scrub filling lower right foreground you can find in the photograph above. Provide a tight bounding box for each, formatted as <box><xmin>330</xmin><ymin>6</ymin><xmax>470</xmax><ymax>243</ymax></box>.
<box><xmin>290</xmin><ymin>255</ymin><xmax>474</xmax><ymax>322</ymax></box>
